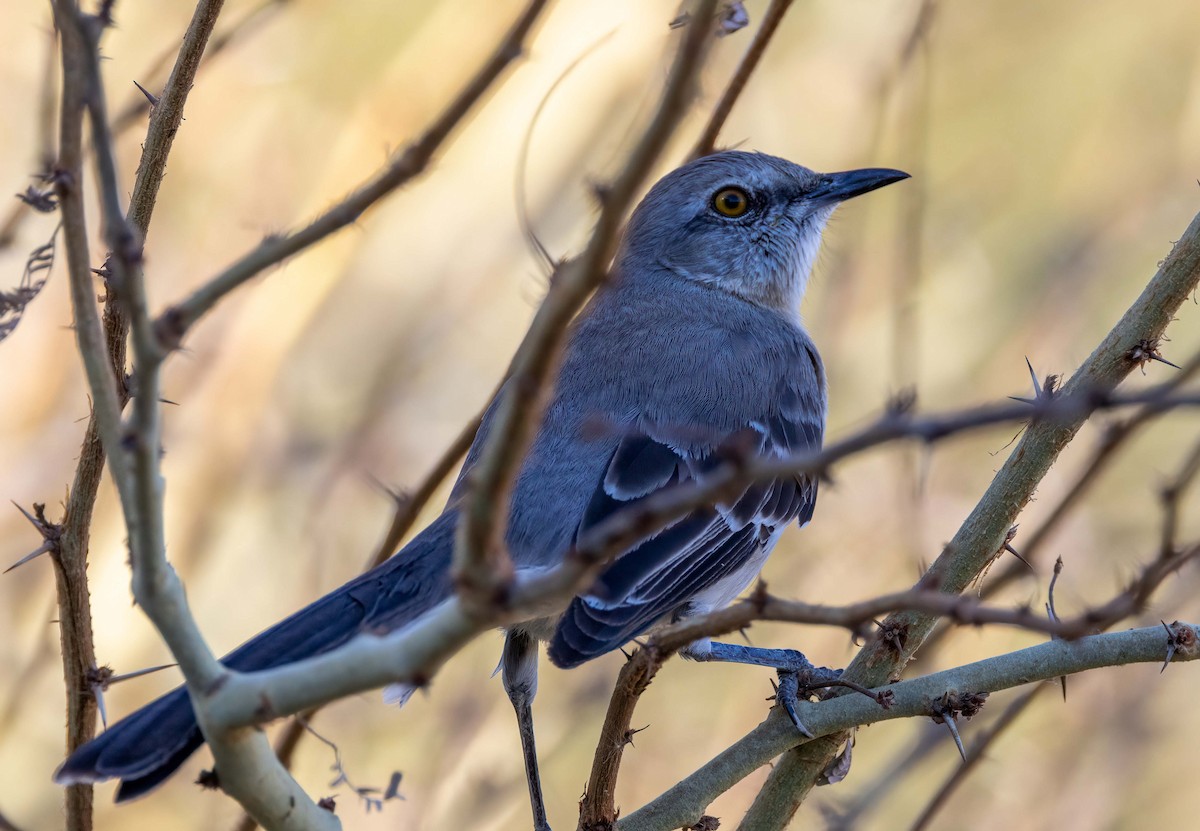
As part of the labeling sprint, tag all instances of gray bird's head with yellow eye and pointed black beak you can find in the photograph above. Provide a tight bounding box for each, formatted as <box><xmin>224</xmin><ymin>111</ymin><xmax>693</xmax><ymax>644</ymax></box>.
<box><xmin>617</xmin><ymin>150</ymin><xmax>908</xmax><ymax>312</ymax></box>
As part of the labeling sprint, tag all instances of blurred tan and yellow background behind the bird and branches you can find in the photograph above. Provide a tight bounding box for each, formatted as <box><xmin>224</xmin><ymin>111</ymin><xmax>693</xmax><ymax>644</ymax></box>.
<box><xmin>0</xmin><ymin>0</ymin><xmax>1200</xmax><ymax>831</ymax></box>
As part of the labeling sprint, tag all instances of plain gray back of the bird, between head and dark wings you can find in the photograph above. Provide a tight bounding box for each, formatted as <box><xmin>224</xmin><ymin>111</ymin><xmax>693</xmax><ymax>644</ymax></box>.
<box><xmin>452</xmin><ymin>270</ymin><xmax>824</xmax><ymax>567</ymax></box>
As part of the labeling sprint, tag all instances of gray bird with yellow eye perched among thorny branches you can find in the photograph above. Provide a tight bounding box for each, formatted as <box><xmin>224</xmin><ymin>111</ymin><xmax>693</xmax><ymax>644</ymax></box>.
<box><xmin>55</xmin><ymin>151</ymin><xmax>907</xmax><ymax>831</ymax></box>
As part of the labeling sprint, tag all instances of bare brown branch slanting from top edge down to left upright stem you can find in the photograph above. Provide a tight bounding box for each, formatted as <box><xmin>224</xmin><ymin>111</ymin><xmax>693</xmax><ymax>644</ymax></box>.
<box><xmin>156</xmin><ymin>0</ymin><xmax>547</xmax><ymax>348</ymax></box>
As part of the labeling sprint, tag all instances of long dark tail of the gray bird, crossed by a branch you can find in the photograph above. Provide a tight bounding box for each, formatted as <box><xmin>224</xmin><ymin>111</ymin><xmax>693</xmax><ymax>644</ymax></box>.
<box><xmin>54</xmin><ymin>513</ymin><xmax>456</xmax><ymax>802</ymax></box>
